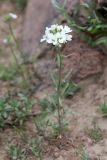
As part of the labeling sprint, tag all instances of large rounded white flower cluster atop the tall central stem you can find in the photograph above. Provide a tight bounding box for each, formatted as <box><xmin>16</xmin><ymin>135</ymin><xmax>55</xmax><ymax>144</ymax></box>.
<box><xmin>41</xmin><ymin>24</ymin><xmax>72</xmax><ymax>47</ymax></box>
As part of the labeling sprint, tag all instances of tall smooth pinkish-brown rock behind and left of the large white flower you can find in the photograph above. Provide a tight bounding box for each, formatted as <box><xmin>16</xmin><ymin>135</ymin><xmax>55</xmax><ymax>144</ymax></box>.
<box><xmin>22</xmin><ymin>0</ymin><xmax>55</xmax><ymax>58</ymax></box>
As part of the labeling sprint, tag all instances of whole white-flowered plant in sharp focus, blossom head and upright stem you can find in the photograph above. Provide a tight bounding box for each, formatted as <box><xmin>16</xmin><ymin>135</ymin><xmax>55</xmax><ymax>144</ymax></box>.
<box><xmin>41</xmin><ymin>24</ymin><xmax>72</xmax><ymax>135</ymax></box>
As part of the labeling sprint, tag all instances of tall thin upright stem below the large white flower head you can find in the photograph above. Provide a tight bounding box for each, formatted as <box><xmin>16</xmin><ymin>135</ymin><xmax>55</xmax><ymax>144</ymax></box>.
<box><xmin>57</xmin><ymin>49</ymin><xmax>62</xmax><ymax>135</ymax></box>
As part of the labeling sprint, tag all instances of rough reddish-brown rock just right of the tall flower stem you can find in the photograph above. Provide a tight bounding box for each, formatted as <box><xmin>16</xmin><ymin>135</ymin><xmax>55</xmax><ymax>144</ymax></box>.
<box><xmin>64</xmin><ymin>42</ymin><xmax>103</xmax><ymax>80</ymax></box>
